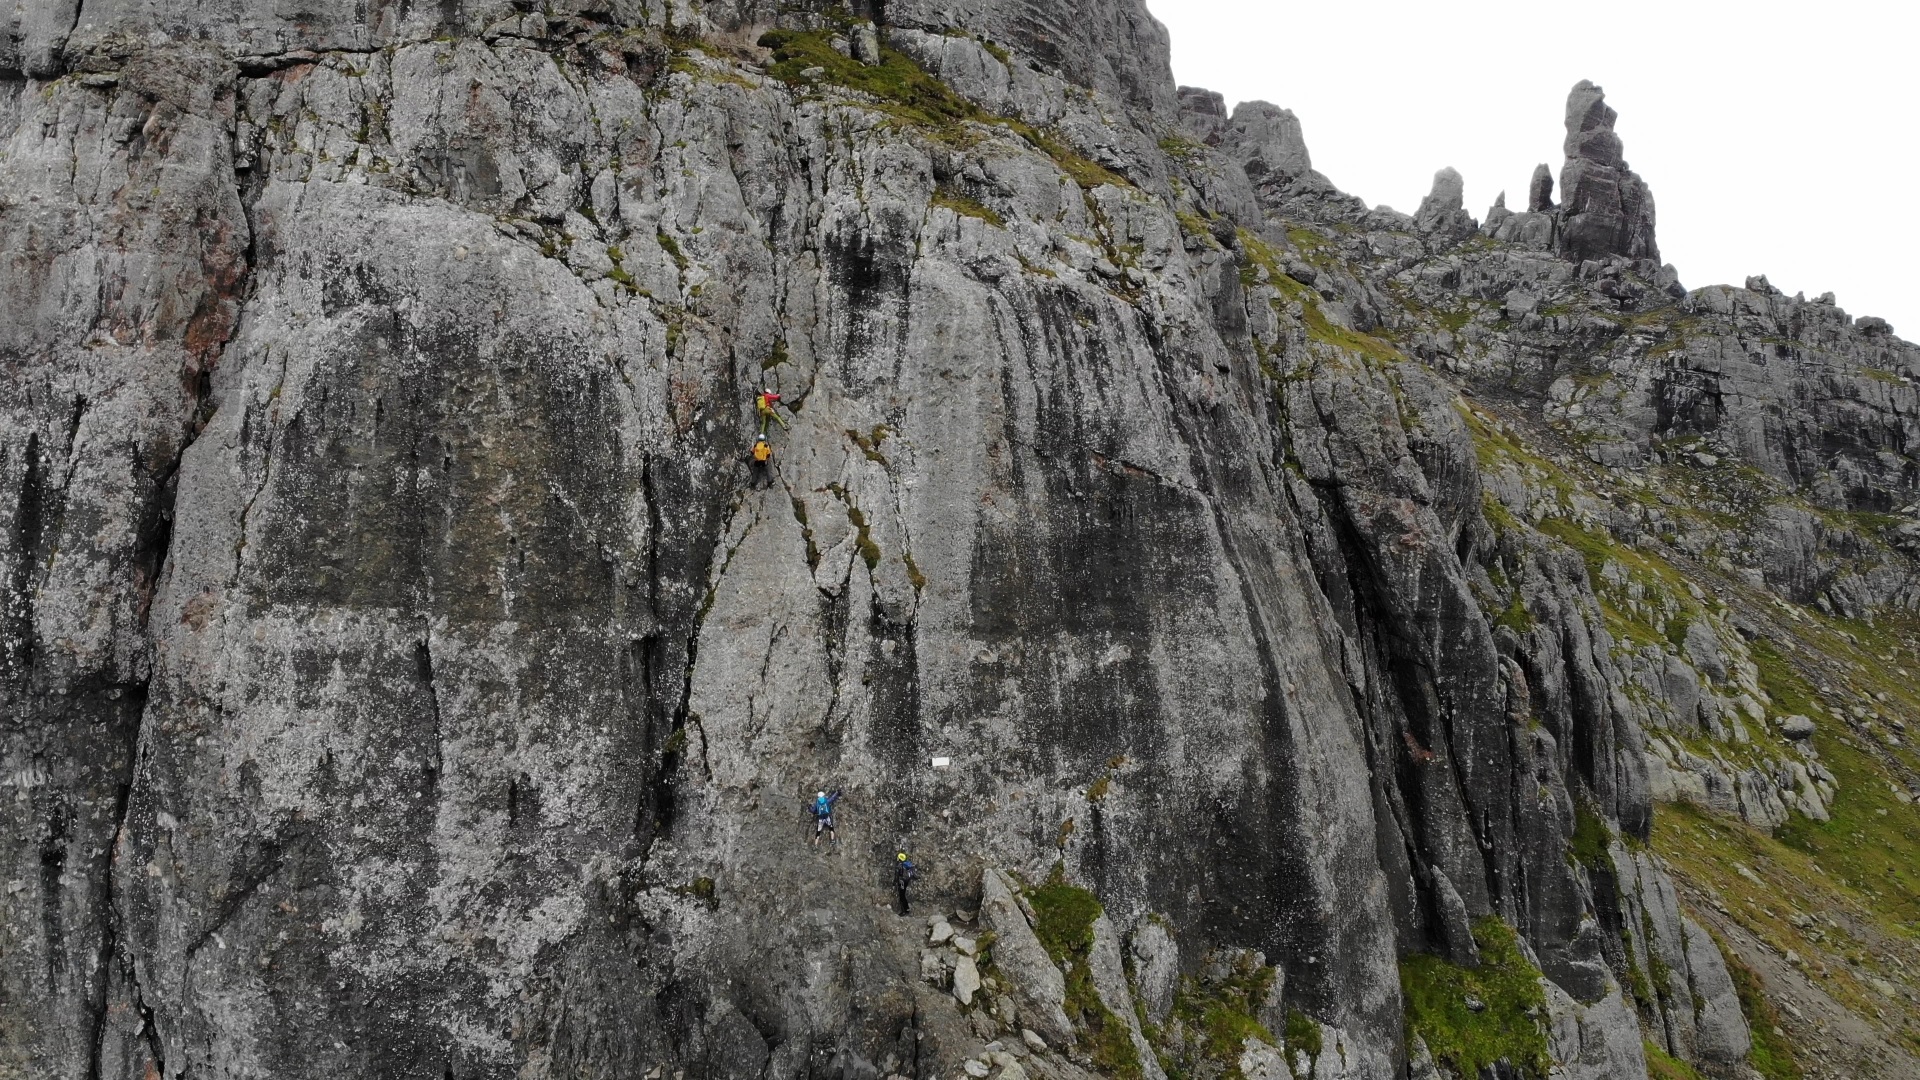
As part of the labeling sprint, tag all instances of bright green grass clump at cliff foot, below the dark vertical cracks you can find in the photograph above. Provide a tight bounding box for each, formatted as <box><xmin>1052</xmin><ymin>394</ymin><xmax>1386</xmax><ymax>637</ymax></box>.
<box><xmin>1400</xmin><ymin>917</ymin><xmax>1551</xmax><ymax>1080</ymax></box>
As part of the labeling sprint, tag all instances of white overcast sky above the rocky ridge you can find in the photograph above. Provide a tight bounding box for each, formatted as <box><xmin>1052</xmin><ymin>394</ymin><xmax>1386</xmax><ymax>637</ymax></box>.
<box><xmin>1148</xmin><ymin>0</ymin><xmax>1920</xmax><ymax>340</ymax></box>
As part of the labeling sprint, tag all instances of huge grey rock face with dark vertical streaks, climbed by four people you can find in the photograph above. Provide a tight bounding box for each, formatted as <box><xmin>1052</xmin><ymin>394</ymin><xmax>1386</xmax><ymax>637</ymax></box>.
<box><xmin>0</xmin><ymin>0</ymin><xmax>1920</xmax><ymax>1080</ymax></box>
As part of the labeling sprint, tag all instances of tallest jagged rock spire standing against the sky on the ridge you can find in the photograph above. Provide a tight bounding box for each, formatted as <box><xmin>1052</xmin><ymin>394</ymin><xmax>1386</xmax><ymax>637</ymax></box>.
<box><xmin>1530</xmin><ymin>79</ymin><xmax>1661</xmax><ymax>263</ymax></box>
